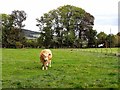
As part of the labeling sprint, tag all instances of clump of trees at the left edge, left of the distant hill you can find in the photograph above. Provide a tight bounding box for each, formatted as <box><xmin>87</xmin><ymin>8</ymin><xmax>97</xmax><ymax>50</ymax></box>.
<box><xmin>0</xmin><ymin>10</ymin><xmax>26</xmax><ymax>47</ymax></box>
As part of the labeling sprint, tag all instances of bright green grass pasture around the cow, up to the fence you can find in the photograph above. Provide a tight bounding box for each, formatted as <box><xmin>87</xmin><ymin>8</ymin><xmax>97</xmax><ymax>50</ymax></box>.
<box><xmin>2</xmin><ymin>49</ymin><xmax>120</xmax><ymax>88</ymax></box>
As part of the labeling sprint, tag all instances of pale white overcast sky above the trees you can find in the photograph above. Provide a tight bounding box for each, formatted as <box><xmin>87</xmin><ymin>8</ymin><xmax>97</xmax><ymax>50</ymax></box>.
<box><xmin>0</xmin><ymin>0</ymin><xmax>119</xmax><ymax>34</ymax></box>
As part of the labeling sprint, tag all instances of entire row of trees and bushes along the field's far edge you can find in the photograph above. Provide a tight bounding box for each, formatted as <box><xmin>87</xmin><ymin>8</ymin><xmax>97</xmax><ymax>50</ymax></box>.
<box><xmin>0</xmin><ymin>5</ymin><xmax>120</xmax><ymax>48</ymax></box>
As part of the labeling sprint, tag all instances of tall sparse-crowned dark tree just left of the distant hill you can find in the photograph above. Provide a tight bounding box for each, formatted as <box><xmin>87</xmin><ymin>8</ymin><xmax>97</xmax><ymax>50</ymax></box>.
<box><xmin>11</xmin><ymin>10</ymin><xmax>27</xmax><ymax>45</ymax></box>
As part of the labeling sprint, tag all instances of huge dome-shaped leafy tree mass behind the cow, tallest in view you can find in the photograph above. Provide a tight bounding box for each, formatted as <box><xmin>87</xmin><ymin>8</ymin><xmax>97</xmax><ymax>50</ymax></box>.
<box><xmin>37</xmin><ymin>5</ymin><xmax>94</xmax><ymax>47</ymax></box>
